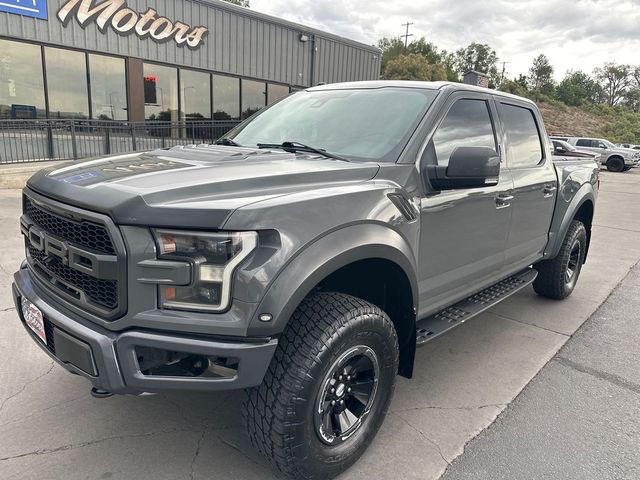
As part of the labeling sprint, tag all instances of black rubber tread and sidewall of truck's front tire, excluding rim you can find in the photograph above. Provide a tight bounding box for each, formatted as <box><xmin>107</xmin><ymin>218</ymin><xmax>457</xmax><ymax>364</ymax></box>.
<box><xmin>243</xmin><ymin>292</ymin><xmax>399</xmax><ymax>480</ymax></box>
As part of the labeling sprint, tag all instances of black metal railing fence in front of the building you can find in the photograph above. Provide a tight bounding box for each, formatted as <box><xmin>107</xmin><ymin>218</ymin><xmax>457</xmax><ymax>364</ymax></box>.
<box><xmin>0</xmin><ymin>120</ymin><xmax>238</xmax><ymax>164</ymax></box>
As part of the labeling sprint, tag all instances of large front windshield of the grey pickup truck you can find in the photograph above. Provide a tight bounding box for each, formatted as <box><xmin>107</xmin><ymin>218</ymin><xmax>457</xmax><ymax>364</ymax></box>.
<box><xmin>228</xmin><ymin>87</ymin><xmax>438</xmax><ymax>162</ymax></box>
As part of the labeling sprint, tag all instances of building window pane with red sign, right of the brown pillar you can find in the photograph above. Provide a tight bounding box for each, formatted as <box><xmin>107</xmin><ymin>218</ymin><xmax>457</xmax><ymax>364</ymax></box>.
<box><xmin>144</xmin><ymin>63</ymin><xmax>178</xmax><ymax>122</ymax></box>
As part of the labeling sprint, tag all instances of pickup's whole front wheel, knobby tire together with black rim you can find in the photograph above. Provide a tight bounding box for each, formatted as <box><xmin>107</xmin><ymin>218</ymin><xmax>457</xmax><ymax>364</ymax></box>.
<box><xmin>244</xmin><ymin>293</ymin><xmax>399</xmax><ymax>480</ymax></box>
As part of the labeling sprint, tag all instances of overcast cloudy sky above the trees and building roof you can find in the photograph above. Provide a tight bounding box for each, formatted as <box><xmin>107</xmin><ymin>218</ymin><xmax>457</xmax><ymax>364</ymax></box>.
<box><xmin>251</xmin><ymin>0</ymin><xmax>640</xmax><ymax>78</ymax></box>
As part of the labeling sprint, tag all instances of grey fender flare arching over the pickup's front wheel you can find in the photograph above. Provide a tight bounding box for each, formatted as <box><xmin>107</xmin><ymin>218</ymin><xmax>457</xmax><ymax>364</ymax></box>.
<box><xmin>247</xmin><ymin>223</ymin><xmax>418</xmax><ymax>336</ymax></box>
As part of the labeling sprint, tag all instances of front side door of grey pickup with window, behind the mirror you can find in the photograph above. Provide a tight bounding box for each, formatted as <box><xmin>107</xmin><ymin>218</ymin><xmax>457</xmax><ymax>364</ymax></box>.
<box><xmin>418</xmin><ymin>92</ymin><xmax>513</xmax><ymax>317</ymax></box>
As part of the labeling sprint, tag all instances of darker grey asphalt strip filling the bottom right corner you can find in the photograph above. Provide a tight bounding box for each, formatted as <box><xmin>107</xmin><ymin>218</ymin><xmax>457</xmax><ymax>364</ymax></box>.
<box><xmin>443</xmin><ymin>267</ymin><xmax>640</xmax><ymax>480</ymax></box>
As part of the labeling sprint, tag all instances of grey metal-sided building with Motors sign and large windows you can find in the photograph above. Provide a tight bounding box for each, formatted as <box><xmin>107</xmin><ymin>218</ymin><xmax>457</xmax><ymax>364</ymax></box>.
<box><xmin>0</xmin><ymin>0</ymin><xmax>380</xmax><ymax>122</ymax></box>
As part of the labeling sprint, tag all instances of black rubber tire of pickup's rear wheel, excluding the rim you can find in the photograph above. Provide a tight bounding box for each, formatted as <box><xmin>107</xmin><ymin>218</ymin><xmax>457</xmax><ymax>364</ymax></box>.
<box><xmin>533</xmin><ymin>220</ymin><xmax>587</xmax><ymax>300</ymax></box>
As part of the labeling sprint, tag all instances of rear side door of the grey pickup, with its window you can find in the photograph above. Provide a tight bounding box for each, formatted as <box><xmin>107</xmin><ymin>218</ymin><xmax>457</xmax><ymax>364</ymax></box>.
<box><xmin>497</xmin><ymin>97</ymin><xmax>558</xmax><ymax>271</ymax></box>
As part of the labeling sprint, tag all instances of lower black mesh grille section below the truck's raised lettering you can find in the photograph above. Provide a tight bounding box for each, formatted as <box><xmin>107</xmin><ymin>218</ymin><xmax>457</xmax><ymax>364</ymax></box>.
<box><xmin>27</xmin><ymin>245</ymin><xmax>118</xmax><ymax>310</ymax></box>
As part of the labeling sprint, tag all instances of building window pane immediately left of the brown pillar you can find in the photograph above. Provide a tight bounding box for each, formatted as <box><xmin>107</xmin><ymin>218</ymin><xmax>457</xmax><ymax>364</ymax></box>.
<box><xmin>89</xmin><ymin>54</ymin><xmax>127</xmax><ymax>120</ymax></box>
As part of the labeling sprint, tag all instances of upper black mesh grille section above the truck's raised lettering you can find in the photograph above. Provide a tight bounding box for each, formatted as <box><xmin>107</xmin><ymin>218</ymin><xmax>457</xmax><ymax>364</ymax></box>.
<box><xmin>24</xmin><ymin>198</ymin><xmax>116</xmax><ymax>255</ymax></box>
